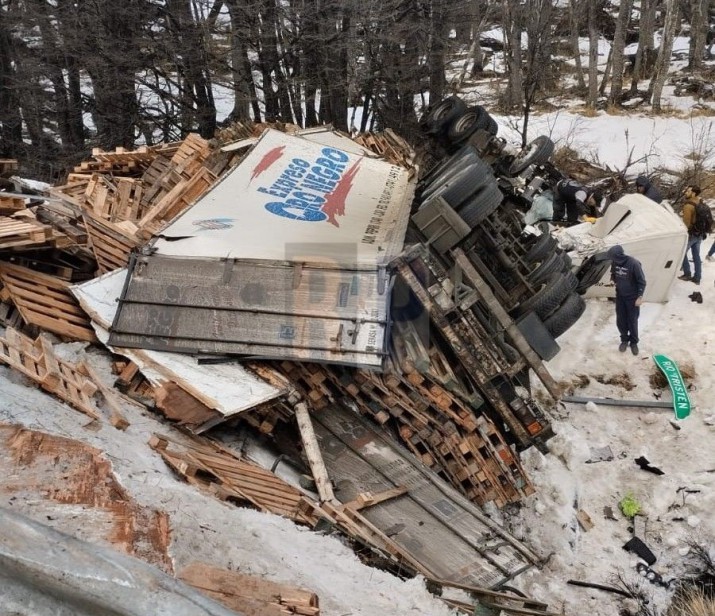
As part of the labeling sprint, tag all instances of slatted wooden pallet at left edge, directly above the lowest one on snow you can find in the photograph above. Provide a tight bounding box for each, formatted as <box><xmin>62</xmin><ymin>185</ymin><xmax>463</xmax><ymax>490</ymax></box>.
<box><xmin>0</xmin><ymin>263</ymin><xmax>97</xmax><ymax>342</ymax></box>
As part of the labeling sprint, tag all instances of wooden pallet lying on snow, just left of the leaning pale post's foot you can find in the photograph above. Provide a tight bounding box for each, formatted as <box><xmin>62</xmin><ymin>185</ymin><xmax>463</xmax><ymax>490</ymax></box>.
<box><xmin>149</xmin><ymin>435</ymin><xmax>320</xmax><ymax>525</ymax></box>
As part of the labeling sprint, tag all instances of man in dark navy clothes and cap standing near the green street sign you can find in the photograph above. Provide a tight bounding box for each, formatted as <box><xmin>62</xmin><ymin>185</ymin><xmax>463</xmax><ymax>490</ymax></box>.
<box><xmin>608</xmin><ymin>244</ymin><xmax>646</xmax><ymax>355</ymax></box>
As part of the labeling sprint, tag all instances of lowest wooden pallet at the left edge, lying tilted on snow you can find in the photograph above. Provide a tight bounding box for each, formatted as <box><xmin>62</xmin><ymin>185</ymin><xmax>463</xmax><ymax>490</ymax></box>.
<box><xmin>0</xmin><ymin>327</ymin><xmax>99</xmax><ymax>419</ymax></box>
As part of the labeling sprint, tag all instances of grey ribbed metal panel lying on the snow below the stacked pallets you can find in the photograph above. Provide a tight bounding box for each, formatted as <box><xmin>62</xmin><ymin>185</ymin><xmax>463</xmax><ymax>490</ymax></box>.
<box><xmin>312</xmin><ymin>406</ymin><xmax>538</xmax><ymax>588</ymax></box>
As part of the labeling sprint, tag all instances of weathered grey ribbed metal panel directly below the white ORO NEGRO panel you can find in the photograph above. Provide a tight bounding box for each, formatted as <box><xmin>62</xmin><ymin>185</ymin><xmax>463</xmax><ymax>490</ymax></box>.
<box><xmin>109</xmin><ymin>255</ymin><xmax>390</xmax><ymax>367</ymax></box>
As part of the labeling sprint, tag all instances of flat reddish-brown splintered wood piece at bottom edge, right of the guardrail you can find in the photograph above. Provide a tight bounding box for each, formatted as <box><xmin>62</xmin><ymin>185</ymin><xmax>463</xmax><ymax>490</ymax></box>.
<box><xmin>178</xmin><ymin>563</ymin><xmax>320</xmax><ymax>616</ymax></box>
